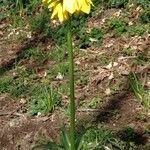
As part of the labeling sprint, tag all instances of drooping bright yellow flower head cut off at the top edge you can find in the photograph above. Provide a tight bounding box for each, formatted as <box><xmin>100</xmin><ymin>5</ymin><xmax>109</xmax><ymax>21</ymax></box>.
<box><xmin>42</xmin><ymin>0</ymin><xmax>93</xmax><ymax>22</ymax></box>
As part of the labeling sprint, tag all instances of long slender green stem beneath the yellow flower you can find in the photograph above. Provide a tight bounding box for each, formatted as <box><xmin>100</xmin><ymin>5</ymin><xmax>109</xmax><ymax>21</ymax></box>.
<box><xmin>67</xmin><ymin>22</ymin><xmax>76</xmax><ymax>150</ymax></box>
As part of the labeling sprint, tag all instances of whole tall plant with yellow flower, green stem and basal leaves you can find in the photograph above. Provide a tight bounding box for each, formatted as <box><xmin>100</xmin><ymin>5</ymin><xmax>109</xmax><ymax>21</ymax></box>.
<box><xmin>34</xmin><ymin>0</ymin><xmax>93</xmax><ymax>150</ymax></box>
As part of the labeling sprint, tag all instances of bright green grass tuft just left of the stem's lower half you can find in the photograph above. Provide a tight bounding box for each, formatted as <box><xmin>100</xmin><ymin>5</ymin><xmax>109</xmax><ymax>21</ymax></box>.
<box><xmin>30</xmin><ymin>85</ymin><xmax>60</xmax><ymax>115</ymax></box>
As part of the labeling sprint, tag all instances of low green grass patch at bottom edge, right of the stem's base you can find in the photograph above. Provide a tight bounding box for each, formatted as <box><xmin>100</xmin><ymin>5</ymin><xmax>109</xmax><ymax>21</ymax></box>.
<box><xmin>82</xmin><ymin>128</ymin><xmax>137</xmax><ymax>150</ymax></box>
